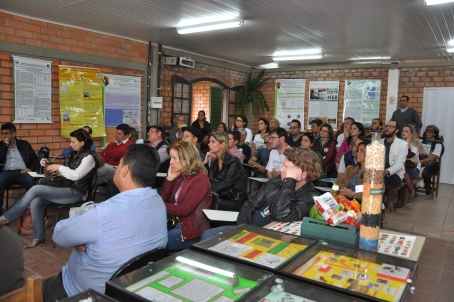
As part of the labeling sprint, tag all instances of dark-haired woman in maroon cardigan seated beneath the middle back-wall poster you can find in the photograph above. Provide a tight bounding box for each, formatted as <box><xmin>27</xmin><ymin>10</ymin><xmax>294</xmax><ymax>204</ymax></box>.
<box><xmin>315</xmin><ymin>124</ymin><xmax>337</xmax><ymax>177</ymax></box>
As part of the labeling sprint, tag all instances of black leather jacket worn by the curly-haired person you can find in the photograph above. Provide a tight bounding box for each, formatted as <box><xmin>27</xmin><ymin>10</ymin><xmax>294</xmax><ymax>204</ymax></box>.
<box><xmin>237</xmin><ymin>175</ymin><xmax>320</xmax><ymax>225</ymax></box>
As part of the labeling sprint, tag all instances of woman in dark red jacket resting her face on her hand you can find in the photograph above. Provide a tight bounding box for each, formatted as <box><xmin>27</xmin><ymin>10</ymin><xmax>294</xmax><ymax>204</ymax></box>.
<box><xmin>161</xmin><ymin>140</ymin><xmax>211</xmax><ymax>251</ymax></box>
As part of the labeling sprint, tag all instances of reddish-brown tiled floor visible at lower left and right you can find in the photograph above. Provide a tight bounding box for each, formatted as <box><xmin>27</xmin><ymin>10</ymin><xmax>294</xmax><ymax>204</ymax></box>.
<box><xmin>3</xmin><ymin>184</ymin><xmax>454</xmax><ymax>302</ymax></box>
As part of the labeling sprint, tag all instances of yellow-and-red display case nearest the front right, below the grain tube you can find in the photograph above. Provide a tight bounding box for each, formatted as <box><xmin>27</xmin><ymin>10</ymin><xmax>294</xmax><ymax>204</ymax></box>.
<box><xmin>278</xmin><ymin>242</ymin><xmax>418</xmax><ymax>302</ymax></box>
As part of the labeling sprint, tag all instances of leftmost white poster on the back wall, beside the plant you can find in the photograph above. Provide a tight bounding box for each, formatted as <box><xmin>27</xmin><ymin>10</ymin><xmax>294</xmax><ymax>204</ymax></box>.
<box><xmin>274</xmin><ymin>79</ymin><xmax>306</xmax><ymax>130</ymax></box>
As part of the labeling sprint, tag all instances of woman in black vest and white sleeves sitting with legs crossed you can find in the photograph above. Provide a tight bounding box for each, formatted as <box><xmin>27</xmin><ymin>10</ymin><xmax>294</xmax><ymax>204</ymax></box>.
<box><xmin>0</xmin><ymin>129</ymin><xmax>97</xmax><ymax>248</ymax></box>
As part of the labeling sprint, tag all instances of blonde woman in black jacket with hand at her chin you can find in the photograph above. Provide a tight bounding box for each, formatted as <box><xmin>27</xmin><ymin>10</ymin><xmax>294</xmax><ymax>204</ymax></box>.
<box><xmin>205</xmin><ymin>131</ymin><xmax>246</xmax><ymax>211</ymax></box>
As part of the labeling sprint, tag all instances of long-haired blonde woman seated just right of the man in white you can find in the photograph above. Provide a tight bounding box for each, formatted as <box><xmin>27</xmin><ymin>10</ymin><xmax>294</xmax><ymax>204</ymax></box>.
<box><xmin>402</xmin><ymin>124</ymin><xmax>424</xmax><ymax>199</ymax></box>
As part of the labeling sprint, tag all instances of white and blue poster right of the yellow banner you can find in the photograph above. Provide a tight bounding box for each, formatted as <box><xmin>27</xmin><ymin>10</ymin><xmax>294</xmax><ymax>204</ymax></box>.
<box><xmin>103</xmin><ymin>74</ymin><xmax>142</xmax><ymax>129</ymax></box>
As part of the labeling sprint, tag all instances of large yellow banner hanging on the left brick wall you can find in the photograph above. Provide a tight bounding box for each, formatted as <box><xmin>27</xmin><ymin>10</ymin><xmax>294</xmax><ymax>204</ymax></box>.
<box><xmin>58</xmin><ymin>65</ymin><xmax>106</xmax><ymax>138</ymax></box>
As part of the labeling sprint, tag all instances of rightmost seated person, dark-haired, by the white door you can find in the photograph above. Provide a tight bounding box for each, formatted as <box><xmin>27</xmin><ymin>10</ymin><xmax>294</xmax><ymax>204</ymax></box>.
<box><xmin>421</xmin><ymin>125</ymin><xmax>445</xmax><ymax>195</ymax></box>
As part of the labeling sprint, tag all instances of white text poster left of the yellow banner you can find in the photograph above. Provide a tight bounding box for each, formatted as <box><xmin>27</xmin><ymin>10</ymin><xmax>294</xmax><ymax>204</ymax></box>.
<box><xmin>13</xmin><ymin>56</ymin><xmax>52</xmax><ymax>123</ymax></box>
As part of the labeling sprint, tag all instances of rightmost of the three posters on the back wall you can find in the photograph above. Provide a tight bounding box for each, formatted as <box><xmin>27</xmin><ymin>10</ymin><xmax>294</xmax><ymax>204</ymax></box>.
<box><xmin>342</xmin><ymin>80</ymin><xmax>381</xmax><ymax>128</ymax></box>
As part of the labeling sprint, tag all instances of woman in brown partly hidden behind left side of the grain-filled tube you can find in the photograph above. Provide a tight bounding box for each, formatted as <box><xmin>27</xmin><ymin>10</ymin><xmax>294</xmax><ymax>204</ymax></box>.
<box><xmin>336</xmin><ymin>142</ymin><xmax>367</xmax><ymax>202</ymax></box>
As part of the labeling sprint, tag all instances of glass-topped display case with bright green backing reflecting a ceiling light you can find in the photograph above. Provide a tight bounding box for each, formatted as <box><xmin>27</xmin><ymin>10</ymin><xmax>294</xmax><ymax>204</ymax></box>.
<box><xmin>106</xmin><ymin>249</ymin><xmax>273</xmax><ymax>302</ymax></box>
